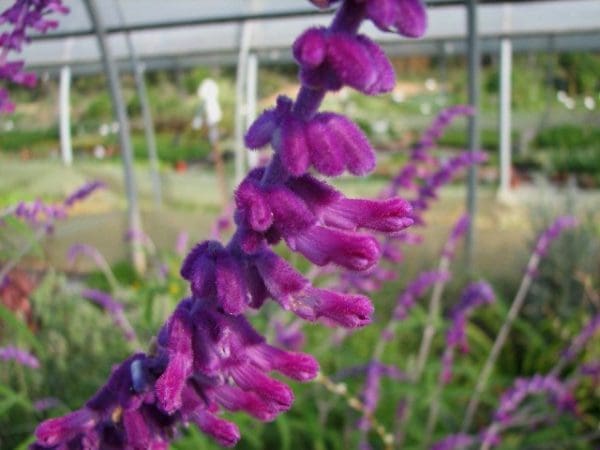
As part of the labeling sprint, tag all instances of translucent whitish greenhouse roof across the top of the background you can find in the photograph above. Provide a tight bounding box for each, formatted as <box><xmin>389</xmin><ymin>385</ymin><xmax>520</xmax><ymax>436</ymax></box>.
<box><xmin>12</xmin><ymin>0</ymin><xmax>600</xmax><ymax>72</ymax></box>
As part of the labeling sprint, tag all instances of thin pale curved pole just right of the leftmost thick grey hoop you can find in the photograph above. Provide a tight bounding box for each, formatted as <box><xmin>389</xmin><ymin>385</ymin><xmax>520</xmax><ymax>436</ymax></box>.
<box><xmin>114</xmin><ymin>0</ymin><xmax>162</xmax><ymax>207</ymax></box>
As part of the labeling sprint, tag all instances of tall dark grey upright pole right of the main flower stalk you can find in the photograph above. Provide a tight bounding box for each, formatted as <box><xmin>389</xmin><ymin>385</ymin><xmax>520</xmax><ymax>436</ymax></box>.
<box><xmin>465</xmin><ymin>0</ymin><xmax>481</xmax><ymax>271</ymax></box>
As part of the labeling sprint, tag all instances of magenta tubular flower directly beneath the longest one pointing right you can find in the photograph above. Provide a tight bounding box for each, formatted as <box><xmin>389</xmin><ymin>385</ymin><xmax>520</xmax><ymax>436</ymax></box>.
<box><xmin>286</xmin><ymin>225</ymin><xmax>380</xmax><ymax>270</ymax></box>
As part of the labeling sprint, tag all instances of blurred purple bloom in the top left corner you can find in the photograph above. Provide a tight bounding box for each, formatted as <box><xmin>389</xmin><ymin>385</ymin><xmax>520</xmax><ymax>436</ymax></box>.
<box><xmin>0</xmin><ymin>0</ymin><xmax>69</xmax><ymax>113</ymax></box>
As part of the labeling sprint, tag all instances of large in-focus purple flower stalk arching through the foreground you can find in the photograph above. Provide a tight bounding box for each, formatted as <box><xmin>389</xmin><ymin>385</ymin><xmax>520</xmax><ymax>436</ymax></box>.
<box><xmin>32</xmin><ymin>0</ymin><xmax>426</xmax><ymax>449</ymax></box>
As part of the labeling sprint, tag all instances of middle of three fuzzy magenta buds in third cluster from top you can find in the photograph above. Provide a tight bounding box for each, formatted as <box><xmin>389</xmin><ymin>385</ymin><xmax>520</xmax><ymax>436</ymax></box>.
<box><xmin>306</xmin><ymin>115</ymin><xmax>344</xmax><ymax>177</ymax></box>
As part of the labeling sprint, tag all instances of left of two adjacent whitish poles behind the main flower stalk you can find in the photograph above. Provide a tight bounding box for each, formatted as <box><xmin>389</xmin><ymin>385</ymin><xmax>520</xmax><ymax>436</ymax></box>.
<box><xmin>235</xmin><ymin>21</ymin><xmax>252</xmax><ymax>185</ymax></box>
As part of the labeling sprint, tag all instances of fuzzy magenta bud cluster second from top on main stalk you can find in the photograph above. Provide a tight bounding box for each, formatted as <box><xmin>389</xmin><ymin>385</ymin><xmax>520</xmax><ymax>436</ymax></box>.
<box><xmin>293</xmin><ymin>28</ymin><xmax>395</xmax><ymax>95</ymax></box>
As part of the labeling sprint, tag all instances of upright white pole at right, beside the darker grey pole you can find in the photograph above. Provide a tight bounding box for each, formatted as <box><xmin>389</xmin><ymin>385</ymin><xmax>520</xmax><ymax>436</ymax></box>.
<box><xmin>498</xmin><ymin>38</ymin><xmax>512</xmax><ymax>199</ymax></box>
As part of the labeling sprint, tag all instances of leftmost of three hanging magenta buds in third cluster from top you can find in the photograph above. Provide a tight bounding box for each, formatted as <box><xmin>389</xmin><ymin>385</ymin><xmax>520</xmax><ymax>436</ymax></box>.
<box><xmin>278</xmin><ymin>115</ymin><xmax>310</xmax><ymax>176</ymax></box>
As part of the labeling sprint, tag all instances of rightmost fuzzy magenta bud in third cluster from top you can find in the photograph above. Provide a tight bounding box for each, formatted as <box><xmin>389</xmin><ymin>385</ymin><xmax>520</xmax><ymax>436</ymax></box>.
<box><xmin>328</xmin><ymin>113</ymin><xmax>375</xmax><ymax>175</ymax></box>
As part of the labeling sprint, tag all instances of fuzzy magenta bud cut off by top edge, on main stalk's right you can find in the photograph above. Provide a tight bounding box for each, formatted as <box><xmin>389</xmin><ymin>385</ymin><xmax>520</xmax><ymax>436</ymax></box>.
<box><xmin>367</xmin><ymin>0</ymin><xmax>427</xmax><ymax>38</ymax></box>
